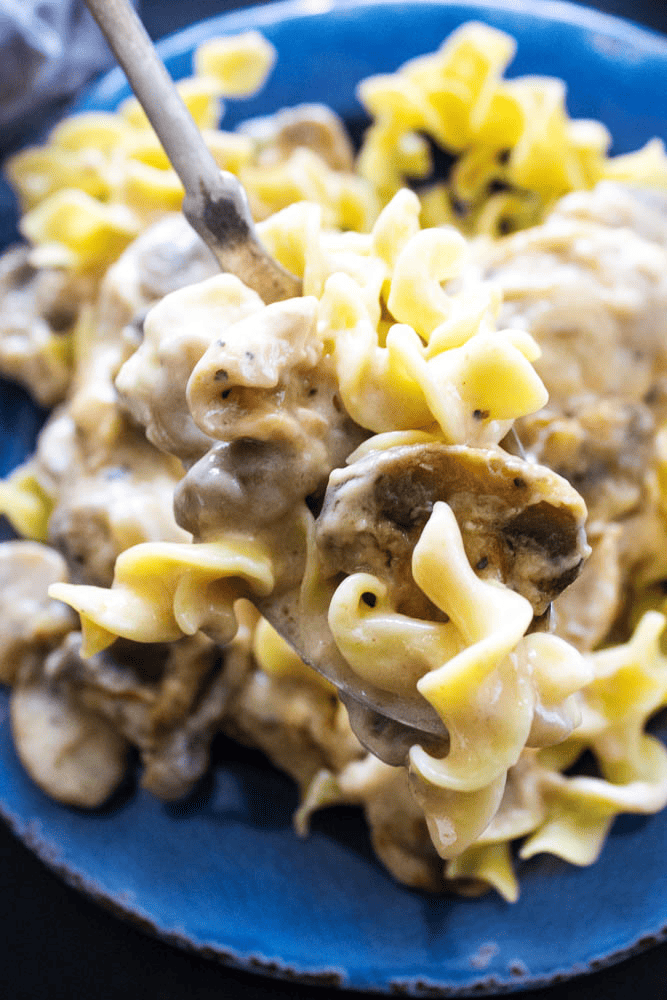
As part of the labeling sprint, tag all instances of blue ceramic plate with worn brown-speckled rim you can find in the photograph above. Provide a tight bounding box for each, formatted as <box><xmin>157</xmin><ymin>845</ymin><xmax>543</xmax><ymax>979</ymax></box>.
<box><xmin>0</xmin><ymin>0</ymin><xmax>667</xmax><ymax>995</ymax></box>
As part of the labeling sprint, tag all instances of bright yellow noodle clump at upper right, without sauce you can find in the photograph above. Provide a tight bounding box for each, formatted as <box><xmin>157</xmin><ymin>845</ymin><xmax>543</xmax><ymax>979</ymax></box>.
<box><xmin>358</xmin><ymin>22</ymin><xmax>667</xmax><ymax>236</ymax></box>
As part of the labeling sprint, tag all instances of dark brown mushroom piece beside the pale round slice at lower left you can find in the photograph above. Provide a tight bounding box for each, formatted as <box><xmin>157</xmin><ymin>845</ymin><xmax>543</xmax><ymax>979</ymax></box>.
<box><xmin>44</xmin><ymin>609</ymin><xmax>256</xmax><ymax>804</ymax></box>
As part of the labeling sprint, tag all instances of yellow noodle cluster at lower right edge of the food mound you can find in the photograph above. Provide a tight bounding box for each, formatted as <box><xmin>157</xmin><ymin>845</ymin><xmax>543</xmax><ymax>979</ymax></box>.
<box><xmin>446</xmin><ymin>611</ymin><xmax>667</xmax><ymax>900</ymax></box>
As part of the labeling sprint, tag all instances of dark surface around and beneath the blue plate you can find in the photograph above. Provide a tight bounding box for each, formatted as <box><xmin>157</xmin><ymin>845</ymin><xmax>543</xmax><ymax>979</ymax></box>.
<box><xmin>0</xmin><ymin>0</ymin><xmax>667</xmax><ymax>1000</ymax></box>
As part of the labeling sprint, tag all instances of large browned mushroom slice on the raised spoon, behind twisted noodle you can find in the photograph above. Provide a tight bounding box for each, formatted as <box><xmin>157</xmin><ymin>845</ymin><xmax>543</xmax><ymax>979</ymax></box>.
<box><xmin>316</xmin><ymin>442</ymin><xmax>589</xmax><ymax>617</ymax></box>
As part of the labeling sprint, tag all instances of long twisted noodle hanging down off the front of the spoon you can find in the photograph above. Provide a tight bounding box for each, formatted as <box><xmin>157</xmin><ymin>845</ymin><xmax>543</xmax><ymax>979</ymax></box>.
<box><xmin>410</xmin><ymin>504</ymin><xmax>590</xmax><ymax>857</ymax></box>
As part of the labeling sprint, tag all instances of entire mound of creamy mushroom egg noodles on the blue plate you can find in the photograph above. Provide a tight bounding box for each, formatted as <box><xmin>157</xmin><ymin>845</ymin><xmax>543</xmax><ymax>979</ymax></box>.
<box><xmin>0</xmin><ymin>23</ymin><xmax>667</xmax><ymax>900</ymax></box>
